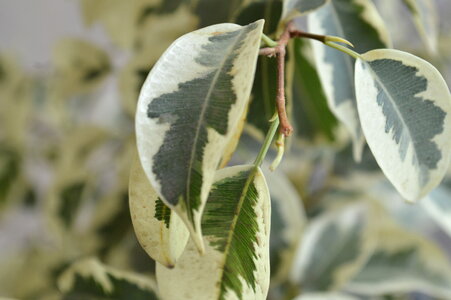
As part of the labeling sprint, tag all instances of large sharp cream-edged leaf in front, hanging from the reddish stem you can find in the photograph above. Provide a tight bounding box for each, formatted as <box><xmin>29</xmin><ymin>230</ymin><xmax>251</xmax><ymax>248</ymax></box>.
<box><xmin>136</xmin><ymin>21</ymin><xmax>263</xmax><ymax>251</ymax></box>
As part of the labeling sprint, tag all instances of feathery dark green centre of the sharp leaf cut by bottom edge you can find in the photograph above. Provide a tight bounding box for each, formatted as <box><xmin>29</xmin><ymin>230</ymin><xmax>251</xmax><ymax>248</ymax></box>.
<box><xmin>202</xmin><ymin>170</ymin><xmax>258</xmax><ymax>300</ymax></box>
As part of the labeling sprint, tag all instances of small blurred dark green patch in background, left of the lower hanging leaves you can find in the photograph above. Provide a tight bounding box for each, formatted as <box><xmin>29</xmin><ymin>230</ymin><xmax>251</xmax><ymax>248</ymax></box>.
<box><xmin>59</xmin><ymin>182</ymin><xmax>85</xmax><ymax>228</ymax></box>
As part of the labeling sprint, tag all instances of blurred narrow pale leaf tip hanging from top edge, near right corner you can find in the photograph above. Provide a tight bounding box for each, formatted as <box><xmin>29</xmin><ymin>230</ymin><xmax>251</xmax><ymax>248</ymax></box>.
<box><xmin>403</xmin><ymin>0</ymin><xmax>438</xmax><ymax>53</ymax></box>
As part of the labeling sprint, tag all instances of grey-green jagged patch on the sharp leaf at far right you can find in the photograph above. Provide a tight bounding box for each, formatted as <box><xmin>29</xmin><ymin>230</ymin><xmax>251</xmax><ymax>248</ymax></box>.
<box><xmin>363</xmin><ymin>59</ymin><xmax>446</xmax><ymax>184</ymax></box>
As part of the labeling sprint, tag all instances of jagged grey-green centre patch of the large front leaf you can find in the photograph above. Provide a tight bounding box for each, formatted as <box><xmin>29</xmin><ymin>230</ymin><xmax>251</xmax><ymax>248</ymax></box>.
<box><xmin>147</xmin><ymin>24</ymin><xmax>257</xmax><ymax>223</ymax></box>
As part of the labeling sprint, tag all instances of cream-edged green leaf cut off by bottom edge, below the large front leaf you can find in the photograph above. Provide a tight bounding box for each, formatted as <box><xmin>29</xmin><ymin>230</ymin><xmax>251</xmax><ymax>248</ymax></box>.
<box><xmin>157</xmin><ymin>166</ymin><xmax>271</xmax><ymax>300</ymax></box>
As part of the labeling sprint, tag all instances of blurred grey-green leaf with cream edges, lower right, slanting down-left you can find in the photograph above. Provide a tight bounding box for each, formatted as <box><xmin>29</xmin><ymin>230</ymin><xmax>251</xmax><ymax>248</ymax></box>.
<box><xmin>291</xmin><ymin>205</ymin><xmax>374</xmax><ymax>292</ymax></box>
